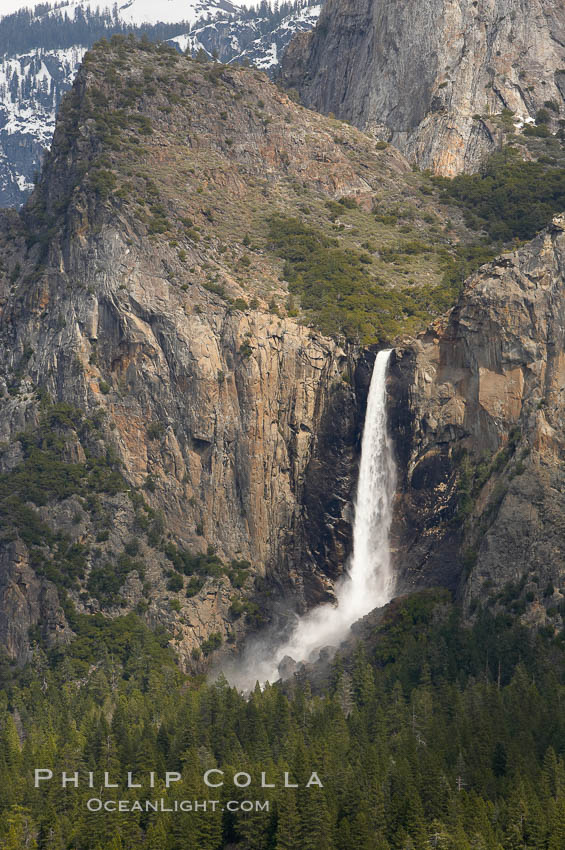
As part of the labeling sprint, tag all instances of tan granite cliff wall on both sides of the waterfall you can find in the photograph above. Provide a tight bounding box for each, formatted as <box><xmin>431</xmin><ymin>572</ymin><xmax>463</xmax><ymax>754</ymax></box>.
<box><xmin>4</xmin><ymin>31</ymin><xmax>565</xmax><ymax>669</ymax></box>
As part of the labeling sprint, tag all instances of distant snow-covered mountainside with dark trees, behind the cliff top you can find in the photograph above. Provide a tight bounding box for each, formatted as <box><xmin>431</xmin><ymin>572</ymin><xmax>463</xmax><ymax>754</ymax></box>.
<box><xmin>0</xmin><ymin>0</ymin><xmax>320</xmax><ymax>207</ymax></box>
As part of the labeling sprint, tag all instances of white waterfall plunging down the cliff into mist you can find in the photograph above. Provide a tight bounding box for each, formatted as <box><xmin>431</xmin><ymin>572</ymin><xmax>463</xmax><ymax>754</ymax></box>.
<box><xmin>226</xmin><ymin>351</ymin><xmax>396</xmax><ymax>687</ymax></box>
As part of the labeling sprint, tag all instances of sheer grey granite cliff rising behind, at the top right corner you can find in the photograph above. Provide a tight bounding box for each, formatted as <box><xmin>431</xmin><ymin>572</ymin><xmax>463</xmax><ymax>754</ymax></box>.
<box><xmin>282</xmin><ymin>0</ymin><xmax>565</xmax><ymax>176</ymax></box>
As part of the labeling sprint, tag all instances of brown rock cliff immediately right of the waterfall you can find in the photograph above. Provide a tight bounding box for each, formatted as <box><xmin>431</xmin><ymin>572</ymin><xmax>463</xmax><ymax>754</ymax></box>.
<box><xmin>391</xmin><ymin>222</ymin><xmax>565</xmax><ymax>619</ymax></box>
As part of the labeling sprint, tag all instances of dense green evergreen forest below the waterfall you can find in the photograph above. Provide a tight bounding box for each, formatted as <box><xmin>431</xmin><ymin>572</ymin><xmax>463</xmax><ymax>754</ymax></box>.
<box><xmin>0</xmin><ymin>591</ymin><xmax>565</xmax><ymax>850</ymax></box>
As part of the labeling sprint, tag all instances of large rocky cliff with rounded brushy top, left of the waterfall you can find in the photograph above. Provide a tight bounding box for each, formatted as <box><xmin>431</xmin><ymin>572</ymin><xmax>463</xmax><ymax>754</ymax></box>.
<box><xmin>0</xmin><ymin>38</ymin><xmax>458</xmax><ymax>664</ymax></box>
